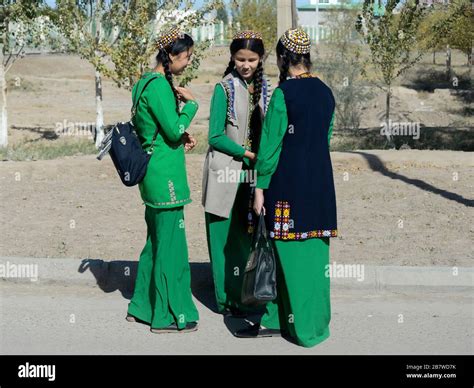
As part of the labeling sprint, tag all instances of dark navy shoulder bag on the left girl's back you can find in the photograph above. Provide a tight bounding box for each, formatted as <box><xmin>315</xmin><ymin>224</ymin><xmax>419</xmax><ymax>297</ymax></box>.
<box><xmin>97</xmin><ymin>77</ymin><xmax>159</xmax><ymax>186</ymax></box>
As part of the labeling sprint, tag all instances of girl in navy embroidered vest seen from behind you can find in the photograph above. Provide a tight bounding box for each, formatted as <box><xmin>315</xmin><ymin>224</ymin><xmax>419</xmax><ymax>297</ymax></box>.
<box><xmin>235</xmin><ymin>29</ymin><xmax>337</xmax><ymax>347</ymax></box>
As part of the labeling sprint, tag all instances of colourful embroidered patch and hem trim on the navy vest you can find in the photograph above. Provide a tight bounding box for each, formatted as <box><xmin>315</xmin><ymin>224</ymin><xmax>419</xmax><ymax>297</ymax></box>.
<box><xmin>270</xmin><ymin>201</ymin><xmax>337</xmax><ymax>240</ymax></box>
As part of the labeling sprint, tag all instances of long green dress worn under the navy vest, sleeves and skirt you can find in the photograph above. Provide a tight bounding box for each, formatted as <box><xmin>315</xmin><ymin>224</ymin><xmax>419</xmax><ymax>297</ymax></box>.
<box><xmin>256</xmin><ymin>88</ymin><xmax>334</xmax><ymax>347</ymax></box>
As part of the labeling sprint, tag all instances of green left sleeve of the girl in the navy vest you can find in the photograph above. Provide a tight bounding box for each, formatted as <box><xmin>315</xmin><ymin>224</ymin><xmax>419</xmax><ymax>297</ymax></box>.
<box><xmin>255</xmin><ymin>88</ymin><xmax>288</xmax><ymax>189</ymax></box>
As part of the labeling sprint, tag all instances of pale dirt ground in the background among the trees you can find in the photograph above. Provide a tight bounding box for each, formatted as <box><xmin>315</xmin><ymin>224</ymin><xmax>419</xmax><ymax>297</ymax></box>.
<box><xmin>7</xmin><ymin>47</ymin><xmax>474</xmax><ymax>152</ymax></box>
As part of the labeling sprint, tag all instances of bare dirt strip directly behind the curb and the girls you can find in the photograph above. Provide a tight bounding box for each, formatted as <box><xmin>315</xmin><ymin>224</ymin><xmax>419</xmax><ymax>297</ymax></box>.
<box><xmin>0</xmin><ymin>150</ymin><xmax>474</xmax><ymax>266</ymax></box>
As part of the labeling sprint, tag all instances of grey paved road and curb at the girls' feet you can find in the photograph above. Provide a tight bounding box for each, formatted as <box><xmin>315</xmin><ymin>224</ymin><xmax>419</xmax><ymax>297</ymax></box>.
<box><xmin>0</xmin><ymin>258</ymin><xmax>474</xmax><ymax>355</ymax></box>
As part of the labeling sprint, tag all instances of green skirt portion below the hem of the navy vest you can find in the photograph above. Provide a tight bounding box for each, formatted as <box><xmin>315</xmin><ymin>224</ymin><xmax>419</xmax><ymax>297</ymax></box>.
<box><xmin>260</xmin><ymin>238</ymin><xmax>331</xmax><ymax>347</ymax></box>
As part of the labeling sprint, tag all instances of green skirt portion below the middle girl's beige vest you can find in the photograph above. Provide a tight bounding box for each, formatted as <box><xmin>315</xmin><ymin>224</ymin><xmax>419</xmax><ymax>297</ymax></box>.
<box><xmin>205</xmin><ymin>183</ymin><xmax>252</xmax><ymax>313</ymax></box>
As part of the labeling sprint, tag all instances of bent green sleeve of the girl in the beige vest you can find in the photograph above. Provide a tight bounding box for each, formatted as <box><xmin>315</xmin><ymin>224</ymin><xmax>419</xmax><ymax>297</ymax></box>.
<box><xmin>209</xmin><ymin>84</ymin><xmax>245</xmax><ymax>158</ymax></box>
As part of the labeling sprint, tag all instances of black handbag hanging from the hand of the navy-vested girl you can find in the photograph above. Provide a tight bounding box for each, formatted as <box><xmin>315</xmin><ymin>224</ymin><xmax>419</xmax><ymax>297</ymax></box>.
<box><xmin>242</xmin><ymin>212</ymin><xmax>277</xmax><ymax>306</ymax></box>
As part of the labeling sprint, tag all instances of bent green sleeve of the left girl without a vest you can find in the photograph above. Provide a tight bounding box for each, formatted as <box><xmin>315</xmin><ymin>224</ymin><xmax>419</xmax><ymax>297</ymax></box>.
<box><xmin>144</xmin><ymin>78</ymin><xmax>198</xmax><ymax>143</ymax></box>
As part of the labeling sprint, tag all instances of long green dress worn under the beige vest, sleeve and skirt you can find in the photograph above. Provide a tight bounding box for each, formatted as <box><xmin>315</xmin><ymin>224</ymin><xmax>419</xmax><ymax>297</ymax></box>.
<box><xmin>205</xmin><ymin>84</ymin><xmax>260</xmax><ymax>313</ymax></box>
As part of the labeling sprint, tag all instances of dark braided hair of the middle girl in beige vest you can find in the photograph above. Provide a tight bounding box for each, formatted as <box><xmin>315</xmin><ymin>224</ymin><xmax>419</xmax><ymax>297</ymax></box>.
<box><xmin>224</xmin><ymin>39</ymin><xmax>265</xmax><ymax>152</ymax></box>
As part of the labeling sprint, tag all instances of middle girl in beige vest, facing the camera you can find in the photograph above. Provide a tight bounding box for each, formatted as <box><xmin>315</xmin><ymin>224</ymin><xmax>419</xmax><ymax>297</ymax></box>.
<box><xmin>202</xmin><ymin>31</ymin><xmax>269</xmax><ymax>316</ymax></box>
